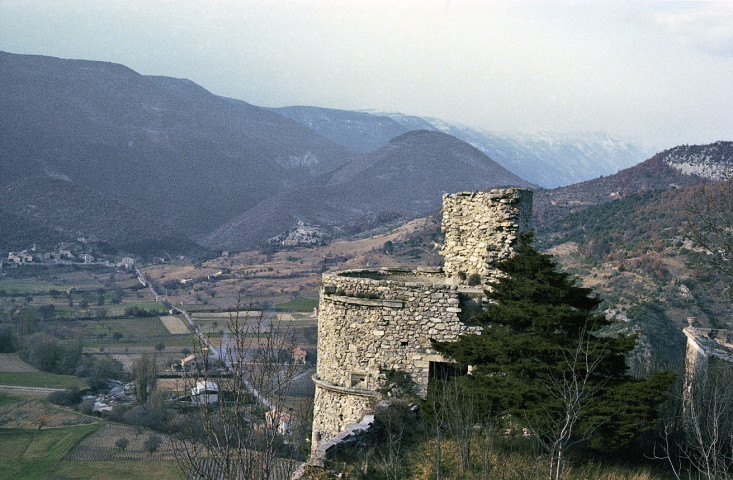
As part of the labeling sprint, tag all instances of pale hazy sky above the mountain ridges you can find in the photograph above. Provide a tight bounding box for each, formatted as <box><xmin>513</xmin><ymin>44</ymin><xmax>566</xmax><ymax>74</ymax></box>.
<box><xmin>0</xmin><ymin>0</ymin><xmax>733</xmax><ymax>146</ymax></box>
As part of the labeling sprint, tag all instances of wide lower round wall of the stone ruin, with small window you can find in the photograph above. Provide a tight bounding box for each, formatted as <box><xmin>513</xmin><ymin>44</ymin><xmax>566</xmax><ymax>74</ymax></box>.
<box><xmin>312</xmin><ymin>271</ymin><xmax>478</xmax><ymax>450</ymax></box>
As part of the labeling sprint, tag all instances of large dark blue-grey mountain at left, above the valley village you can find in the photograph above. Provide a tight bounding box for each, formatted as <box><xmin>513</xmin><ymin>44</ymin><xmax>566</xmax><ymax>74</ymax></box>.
<box><xmin>0</xmin><ymin>52</ymin><xmax>351</xmax><ymax>234</ymax></box>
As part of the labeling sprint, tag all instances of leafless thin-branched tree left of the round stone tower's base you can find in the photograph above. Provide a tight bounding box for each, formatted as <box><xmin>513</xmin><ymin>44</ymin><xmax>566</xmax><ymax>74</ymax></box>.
<box><xmin>175</xmin><ymin>302</ymin><xmax>303</xmax><ymax>480</ymax></box>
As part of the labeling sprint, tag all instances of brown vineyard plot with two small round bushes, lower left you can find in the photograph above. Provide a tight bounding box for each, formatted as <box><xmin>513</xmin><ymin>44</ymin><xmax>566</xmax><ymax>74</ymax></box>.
<box><xmin>66</xmin><ymin>423</ymin><xmax>175</xmax><ymax>461</ymax></box>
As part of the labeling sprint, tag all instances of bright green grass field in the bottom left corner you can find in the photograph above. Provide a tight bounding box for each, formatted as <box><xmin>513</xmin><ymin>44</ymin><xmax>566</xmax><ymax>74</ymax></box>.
<box><xmin>0</xmin><ymin>425</ymin><xmax>99</xmax><ymax>480</ymax></box>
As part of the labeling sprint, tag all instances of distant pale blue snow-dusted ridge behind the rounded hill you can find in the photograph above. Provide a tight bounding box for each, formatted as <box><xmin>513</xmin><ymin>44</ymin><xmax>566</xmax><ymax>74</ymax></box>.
<box><xmin>273</xmin><ymin>107</ymin><xmax>655</xmax><ymax>188</ymax></box>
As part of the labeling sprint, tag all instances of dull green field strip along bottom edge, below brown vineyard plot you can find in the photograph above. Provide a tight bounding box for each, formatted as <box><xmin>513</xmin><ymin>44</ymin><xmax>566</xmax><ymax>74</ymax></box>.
<box><xmin>53</xmin><ymin>460</ymin><xmax>183</xmax><ymax>480</ymax></box>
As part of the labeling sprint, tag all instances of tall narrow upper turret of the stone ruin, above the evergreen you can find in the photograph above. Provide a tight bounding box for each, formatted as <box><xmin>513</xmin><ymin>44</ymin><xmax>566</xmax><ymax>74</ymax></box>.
<box><xmin>440</xmin><ymin>188</ymin><xmax>532</xmax><ymax>285</ymax></box>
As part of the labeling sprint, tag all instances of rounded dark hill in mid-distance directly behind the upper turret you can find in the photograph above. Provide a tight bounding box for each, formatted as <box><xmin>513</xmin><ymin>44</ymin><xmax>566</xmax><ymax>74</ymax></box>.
<box><xmin>204</xmin><ymin>131</ymin><xmax>532</xmax><ymax>250</ymax></box>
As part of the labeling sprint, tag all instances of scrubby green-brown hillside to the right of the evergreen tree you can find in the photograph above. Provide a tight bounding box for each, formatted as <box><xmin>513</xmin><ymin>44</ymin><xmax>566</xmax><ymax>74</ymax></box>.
<box><xmin>538</xmin><ymin>185</ymin><xmax>733</xmax><ymax>365</ymax></box>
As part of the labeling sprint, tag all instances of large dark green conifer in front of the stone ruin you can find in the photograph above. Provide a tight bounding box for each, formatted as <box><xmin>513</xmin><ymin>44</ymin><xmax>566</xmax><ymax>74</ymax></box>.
<box><xmin>433</xmin><ymin>234</ymin><xmax>672</xmax><ymax>450</ymax></box>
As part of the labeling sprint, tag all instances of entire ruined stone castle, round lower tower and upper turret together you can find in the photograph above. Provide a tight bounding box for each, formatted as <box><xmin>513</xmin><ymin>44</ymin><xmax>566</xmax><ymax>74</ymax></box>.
<box><xmin>311</xmin><ymin>188</ymin><xmax>532</xmax><ymax>454</ymax></box>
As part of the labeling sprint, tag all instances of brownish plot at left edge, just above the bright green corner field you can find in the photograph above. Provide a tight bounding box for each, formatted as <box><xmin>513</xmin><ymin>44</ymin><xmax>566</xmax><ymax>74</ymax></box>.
<box><xmin>0</xmin><ymin>399</ymin><xmax>98</xmax><ymax>429</ymax></box>
